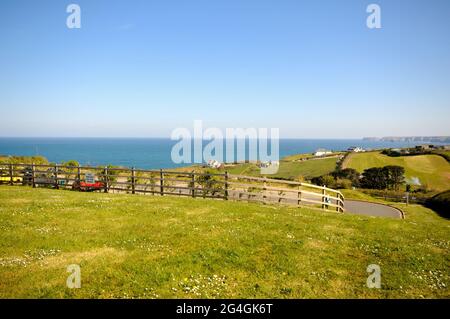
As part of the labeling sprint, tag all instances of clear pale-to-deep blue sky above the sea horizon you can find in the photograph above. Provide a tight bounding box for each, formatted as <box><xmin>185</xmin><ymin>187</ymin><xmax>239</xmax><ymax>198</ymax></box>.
<box><xmin>0</xmin><ymin>0</ymin><xmax>450</xmax><ymax>138</ymax></box>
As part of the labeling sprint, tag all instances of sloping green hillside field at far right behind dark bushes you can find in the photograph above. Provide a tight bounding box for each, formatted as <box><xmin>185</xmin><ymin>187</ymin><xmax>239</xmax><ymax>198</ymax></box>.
<box><xmin>344</xmin><ymin>152</ymin><xmax>450</xmax><ymax>191</ymax></box>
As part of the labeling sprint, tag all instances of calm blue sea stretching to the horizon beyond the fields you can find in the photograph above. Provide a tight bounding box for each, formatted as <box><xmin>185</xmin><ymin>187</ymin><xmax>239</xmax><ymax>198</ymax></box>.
<box><xmin>0</xmin><ymin>137</ymin><xmax>434</xmax><ymax>169</ymax></box>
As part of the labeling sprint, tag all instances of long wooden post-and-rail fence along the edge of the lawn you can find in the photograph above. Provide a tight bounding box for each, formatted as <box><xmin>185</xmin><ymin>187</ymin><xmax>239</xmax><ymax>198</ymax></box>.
<box><xmin>0</xmin><ymin>164</ymin><xmax>344</xmax><ymax>212</ymax></box>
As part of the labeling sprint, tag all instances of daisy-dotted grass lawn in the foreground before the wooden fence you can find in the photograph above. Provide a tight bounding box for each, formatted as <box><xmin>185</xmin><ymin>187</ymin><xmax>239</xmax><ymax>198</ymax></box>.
<box><xmin>0</xmin><ymin>186</ymin><xmax>450</xmax><ymax>298</ymax></box>
